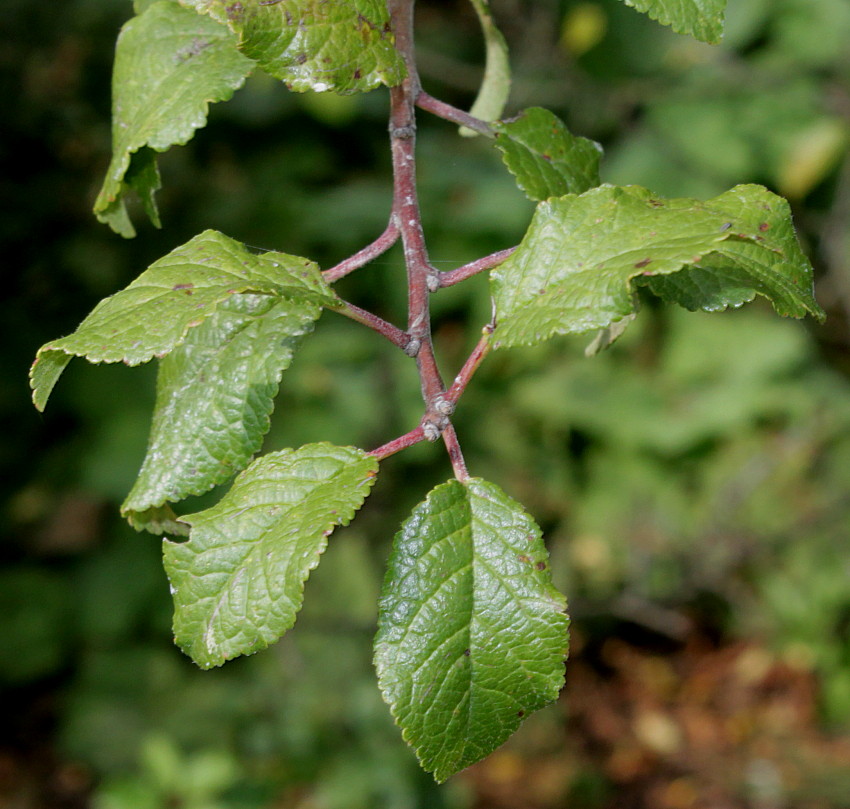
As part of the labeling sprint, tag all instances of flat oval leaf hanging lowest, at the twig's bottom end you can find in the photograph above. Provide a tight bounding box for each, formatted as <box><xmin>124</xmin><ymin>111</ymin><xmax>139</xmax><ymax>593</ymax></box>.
<box><xmin>375</xmin><ymin>478</ymin><xmax>569</xmax><ymax>781</ymax></box>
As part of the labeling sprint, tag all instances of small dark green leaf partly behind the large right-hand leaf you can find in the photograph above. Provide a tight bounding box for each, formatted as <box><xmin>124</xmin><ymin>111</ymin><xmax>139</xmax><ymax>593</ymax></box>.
<box><xmin>494</xmin><ymin>107</ymin><xmax>602</xmax><ymax>202</ymax></box>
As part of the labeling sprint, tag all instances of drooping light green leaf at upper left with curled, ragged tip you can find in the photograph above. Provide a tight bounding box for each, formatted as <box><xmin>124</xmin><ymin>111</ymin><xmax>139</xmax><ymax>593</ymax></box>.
<box><xmin>94</xmin><ymin>1</ymin><xmax>254</xmax><ymax>238</ymax></box>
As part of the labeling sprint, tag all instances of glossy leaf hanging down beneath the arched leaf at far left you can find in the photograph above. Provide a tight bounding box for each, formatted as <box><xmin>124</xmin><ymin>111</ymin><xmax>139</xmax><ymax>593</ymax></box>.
<box><xmin>122</xmin><ymin>295</ymin><xmax>321</xmax><ymax>533</ymax></box>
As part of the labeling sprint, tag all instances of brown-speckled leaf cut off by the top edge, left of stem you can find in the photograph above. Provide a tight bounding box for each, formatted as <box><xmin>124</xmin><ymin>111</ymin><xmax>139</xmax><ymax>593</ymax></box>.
<box><xmin>180</xmin><ymin>0</ymin><xmax>404</xmax><ymax>93</ymax></box>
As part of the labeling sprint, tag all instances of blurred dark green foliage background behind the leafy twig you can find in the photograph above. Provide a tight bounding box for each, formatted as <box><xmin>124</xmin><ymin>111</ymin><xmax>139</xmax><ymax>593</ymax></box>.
<box><xmin>0</xmin><ymin>0</ymin><xmax>850</xmax><ymax>809</ymax></box>
